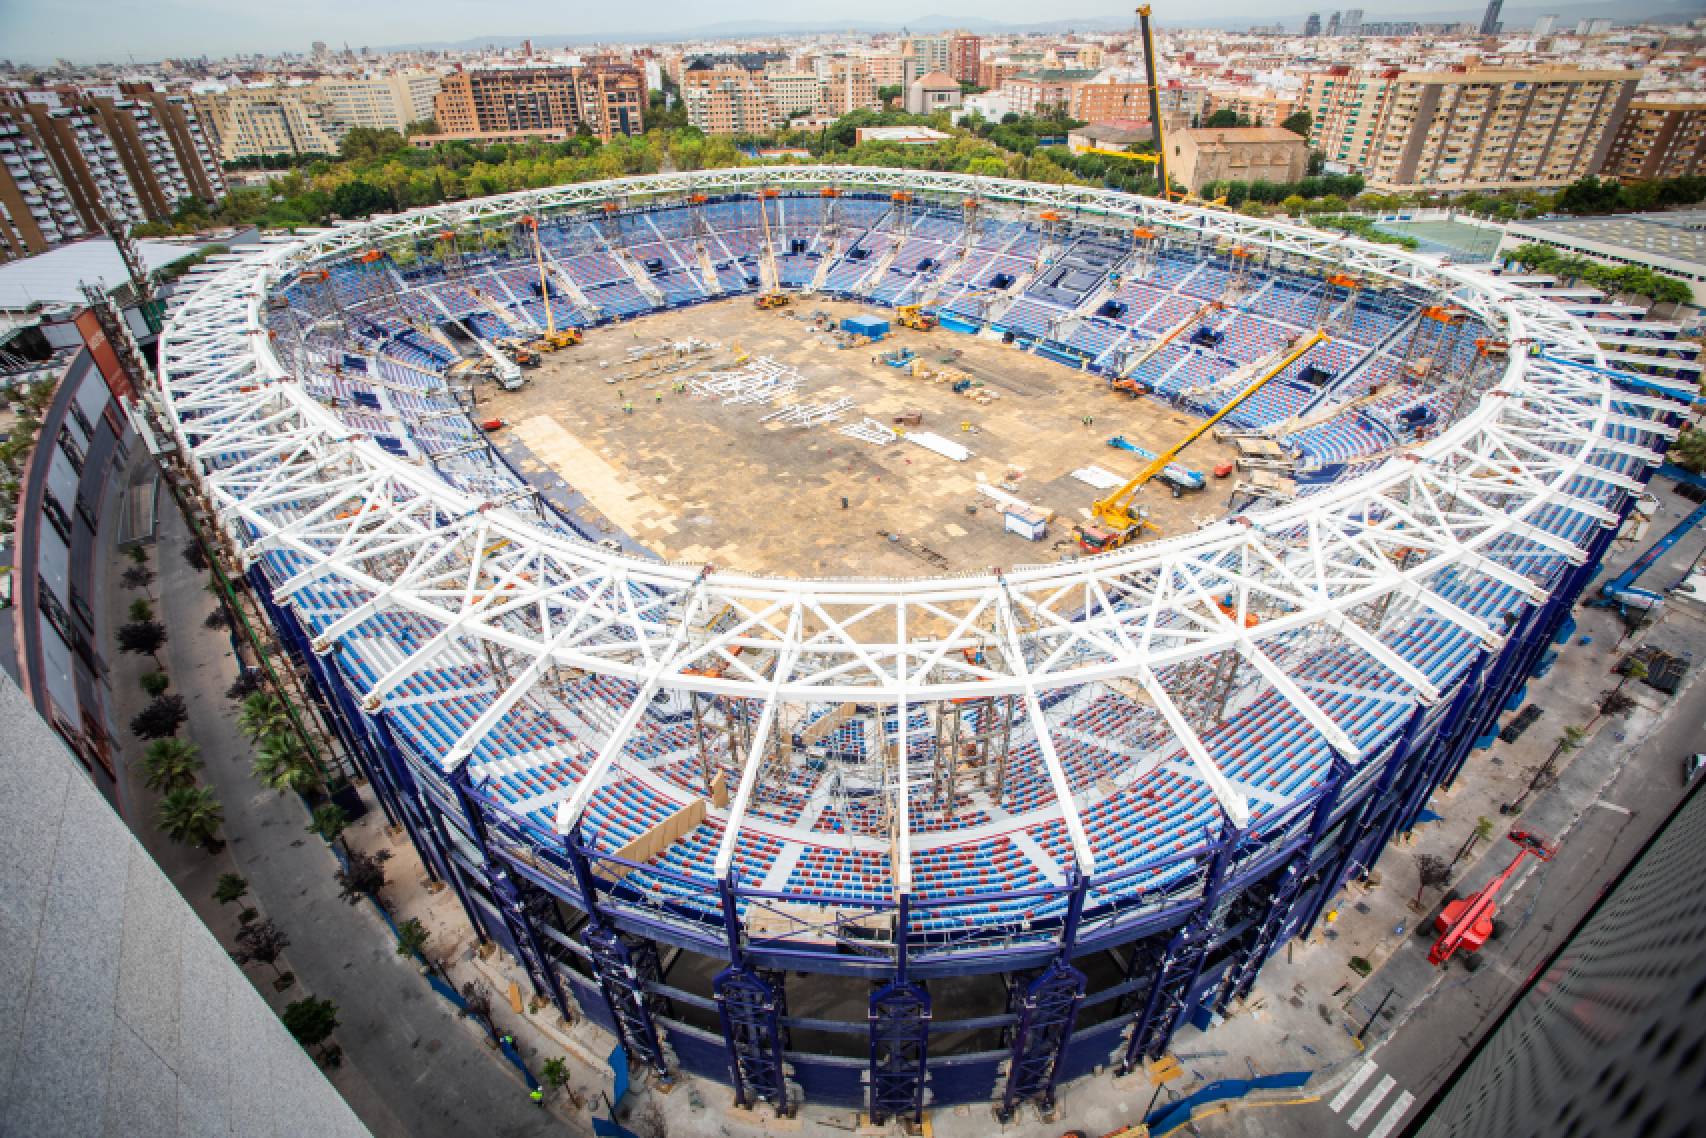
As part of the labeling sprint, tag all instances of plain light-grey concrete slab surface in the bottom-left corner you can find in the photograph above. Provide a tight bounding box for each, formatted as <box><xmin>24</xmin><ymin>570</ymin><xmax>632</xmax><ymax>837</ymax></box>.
<box><xmin>0</xmin><ymin>677</ymin><xmax>368</xmax><ymax>1138</ymax></box>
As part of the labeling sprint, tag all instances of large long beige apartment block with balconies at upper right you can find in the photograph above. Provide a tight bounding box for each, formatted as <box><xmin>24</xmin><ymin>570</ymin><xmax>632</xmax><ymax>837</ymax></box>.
<box><xmin>1300</xmin><ymin>67</ymin><xmax>1639</xmax><ymax>191</ymax></box>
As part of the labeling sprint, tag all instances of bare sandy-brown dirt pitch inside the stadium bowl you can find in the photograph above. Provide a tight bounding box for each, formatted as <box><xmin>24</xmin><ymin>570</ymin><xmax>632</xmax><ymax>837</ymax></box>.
<box><xmin>481</xmin><ymin>297</ymin><xmax>1232</xmax><ymax>577</ymax></box>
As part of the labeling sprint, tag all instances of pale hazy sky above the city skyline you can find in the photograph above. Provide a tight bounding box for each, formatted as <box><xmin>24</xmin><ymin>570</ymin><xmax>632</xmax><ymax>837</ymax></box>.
<box><xmin>0</xmin><ymin>0</ymin><xmax>1513</xmax><ymax>63</ymax></box>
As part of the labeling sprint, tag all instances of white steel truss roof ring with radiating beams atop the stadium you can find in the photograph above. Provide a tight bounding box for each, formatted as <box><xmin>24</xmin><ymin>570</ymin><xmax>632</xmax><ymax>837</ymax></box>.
<box><xmin>159</xmin><ymin>165</ymin><xmax>1680</xmax><ymax>891</ymax></box>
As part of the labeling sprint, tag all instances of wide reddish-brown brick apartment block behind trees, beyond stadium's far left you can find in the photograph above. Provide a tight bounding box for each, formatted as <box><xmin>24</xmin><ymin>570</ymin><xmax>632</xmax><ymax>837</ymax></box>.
<box><xmin>433</xmin><ymin>63</ymin><xmax>645</xmax><ymax>140</ymax></box>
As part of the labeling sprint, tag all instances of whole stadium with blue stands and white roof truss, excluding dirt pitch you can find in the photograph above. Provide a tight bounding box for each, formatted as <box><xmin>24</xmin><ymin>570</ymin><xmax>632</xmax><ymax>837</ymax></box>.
<box><xmin>160</xmin><ymin>167</ymin><xmax>1686</xmax><ymax>1119</ymax></box>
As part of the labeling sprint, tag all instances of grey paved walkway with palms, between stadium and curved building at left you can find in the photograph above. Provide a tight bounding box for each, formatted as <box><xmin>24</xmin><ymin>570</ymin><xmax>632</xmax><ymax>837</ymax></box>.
<box><xmin>113</xmin><ymin>494</ymin><xmax>585</xmax><ymax>1138</ymax></box>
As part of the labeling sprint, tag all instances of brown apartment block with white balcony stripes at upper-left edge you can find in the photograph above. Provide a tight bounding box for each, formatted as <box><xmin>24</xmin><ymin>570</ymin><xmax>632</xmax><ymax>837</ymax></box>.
<box><xmin>0</xmin><ymin>85</ymin><xmax>225</xmax><ymax>259</ymax></box>
